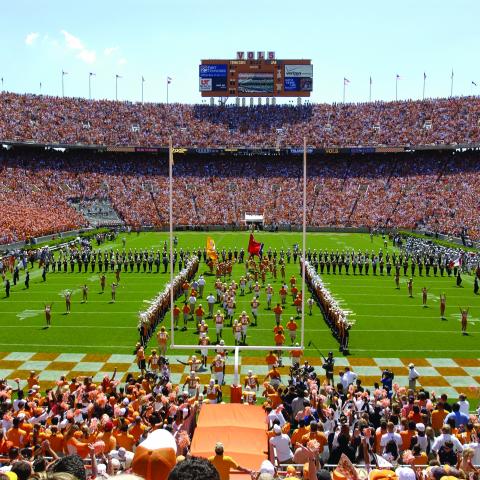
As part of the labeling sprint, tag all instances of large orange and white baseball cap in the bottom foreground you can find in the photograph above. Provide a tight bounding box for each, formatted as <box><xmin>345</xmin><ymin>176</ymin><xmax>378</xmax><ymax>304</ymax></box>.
<box><xmin>132</xmin><ymin>429</ymin><xmax>177</xmax><ymax>480</ymax></box>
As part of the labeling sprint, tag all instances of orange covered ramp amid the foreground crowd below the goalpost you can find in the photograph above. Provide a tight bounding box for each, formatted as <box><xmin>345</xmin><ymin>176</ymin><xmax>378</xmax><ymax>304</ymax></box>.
<box><xmin>191</xmin><ymin>403</ymin><xmax>268</xmax><ymax>470</ymax></box>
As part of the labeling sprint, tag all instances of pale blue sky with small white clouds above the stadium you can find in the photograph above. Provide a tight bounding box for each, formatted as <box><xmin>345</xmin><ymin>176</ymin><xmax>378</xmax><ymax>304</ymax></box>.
<box><xmin>0</xmin><ymin>0</ymin><xmax>480</xmax><ymax>103</ymax></box>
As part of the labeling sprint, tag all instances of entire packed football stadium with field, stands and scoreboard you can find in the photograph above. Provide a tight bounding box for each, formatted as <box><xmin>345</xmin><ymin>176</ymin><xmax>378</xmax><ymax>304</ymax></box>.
<box><xmin>0</xmin><ymin>4</ymin><xmax>480</xmax><ymax>480</ymax></box>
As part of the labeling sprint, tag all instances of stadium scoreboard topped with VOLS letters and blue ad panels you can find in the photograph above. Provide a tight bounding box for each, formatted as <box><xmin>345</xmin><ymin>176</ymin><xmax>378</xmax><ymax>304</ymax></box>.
<box><xmin>199</xmin><ymin>52</ymin><xmax>313</xmax><ymax>98</ymax></box>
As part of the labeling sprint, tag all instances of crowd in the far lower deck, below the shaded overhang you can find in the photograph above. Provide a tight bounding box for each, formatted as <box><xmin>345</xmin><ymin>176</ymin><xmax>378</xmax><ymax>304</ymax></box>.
<box><xmin>0</xmin><ymin>148</ymin><xmax>480</xmax><ymax>243</ymax></box>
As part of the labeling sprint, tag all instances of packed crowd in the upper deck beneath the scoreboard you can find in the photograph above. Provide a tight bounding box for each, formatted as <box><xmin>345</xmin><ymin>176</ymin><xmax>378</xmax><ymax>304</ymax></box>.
<box><xmin>0</xmin><ymin>92</ymin><xmax>480</xmax><ymax>147</ymax></box>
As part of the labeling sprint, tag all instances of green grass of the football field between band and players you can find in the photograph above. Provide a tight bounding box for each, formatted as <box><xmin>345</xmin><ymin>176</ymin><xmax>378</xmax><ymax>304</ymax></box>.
<box><xmin>0</xmin><ymin>232</ymin><xmax>480</xmax><ymax>358</ymax></box>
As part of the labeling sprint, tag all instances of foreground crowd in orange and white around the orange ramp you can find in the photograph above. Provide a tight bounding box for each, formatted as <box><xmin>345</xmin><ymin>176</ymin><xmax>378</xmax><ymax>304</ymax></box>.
<box><xmin>0</xmin><ymin>354</ymin><xmax>480</xmax><ymax>480</ymax></box>
